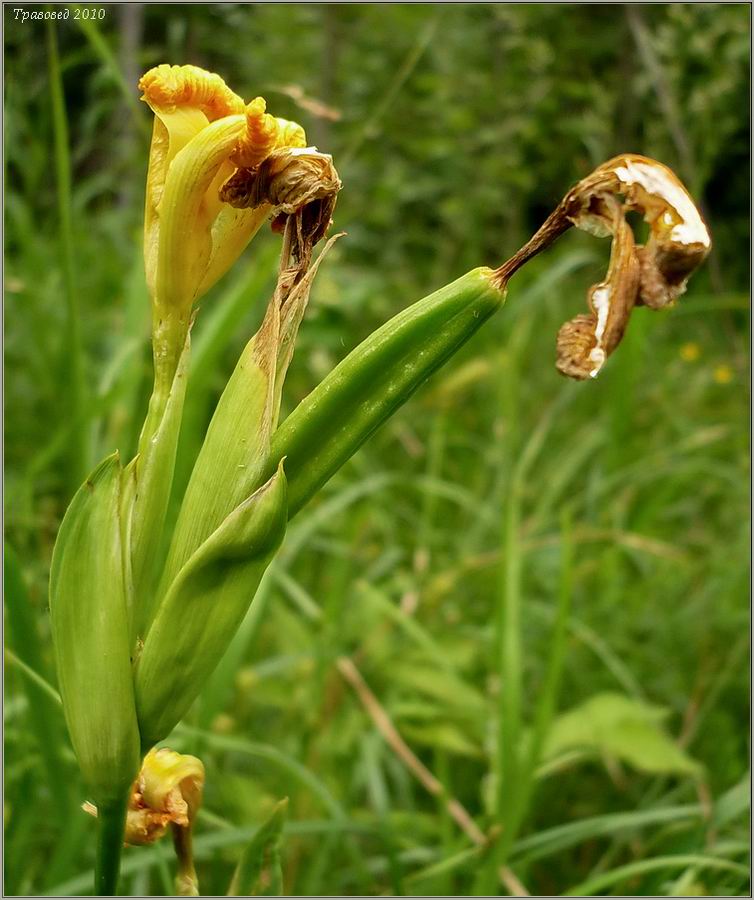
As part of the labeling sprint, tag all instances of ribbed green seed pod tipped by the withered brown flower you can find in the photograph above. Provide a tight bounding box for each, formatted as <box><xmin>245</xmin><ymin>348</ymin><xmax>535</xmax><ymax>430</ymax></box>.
<box><xmin>268</xmin><ymin>268</ymin><xmax>505</xmax><ymax>516</ymax></box>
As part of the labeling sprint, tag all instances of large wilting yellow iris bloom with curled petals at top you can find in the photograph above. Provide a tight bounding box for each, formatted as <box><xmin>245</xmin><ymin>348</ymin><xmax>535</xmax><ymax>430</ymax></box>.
<box><xmin>139</xmin><ymin>65</ymin><xmax>306</xmax><ymax>323</ymax></box>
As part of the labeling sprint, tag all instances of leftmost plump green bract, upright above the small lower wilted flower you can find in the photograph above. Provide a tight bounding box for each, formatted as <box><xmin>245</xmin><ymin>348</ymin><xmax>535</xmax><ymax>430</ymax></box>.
<box><xmin>50</xmin><ymin>453</ymin><xmax>140</xmax><ymax>807</ymax></box>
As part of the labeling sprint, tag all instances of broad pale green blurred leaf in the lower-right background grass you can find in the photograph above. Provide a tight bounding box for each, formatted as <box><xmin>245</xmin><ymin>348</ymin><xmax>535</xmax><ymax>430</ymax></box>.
<box><xmin>545</xmin><ymin>693</ymin><xmax>700</xmax><ymax>775</ymax></box>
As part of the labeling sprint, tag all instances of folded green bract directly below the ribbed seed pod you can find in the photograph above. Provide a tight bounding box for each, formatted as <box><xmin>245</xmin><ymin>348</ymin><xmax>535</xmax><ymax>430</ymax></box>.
<box><xmin>135</xmin><ymin>464</ymin><xmax>288</xmax><ymax>750</ymax></box>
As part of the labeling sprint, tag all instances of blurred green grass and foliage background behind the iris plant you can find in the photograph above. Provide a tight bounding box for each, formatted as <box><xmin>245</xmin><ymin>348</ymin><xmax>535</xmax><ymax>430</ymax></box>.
<box><xmin>3</xmin><ymin>4</ymin><xmax>750</xmax><ymax>895</ymax></box>
